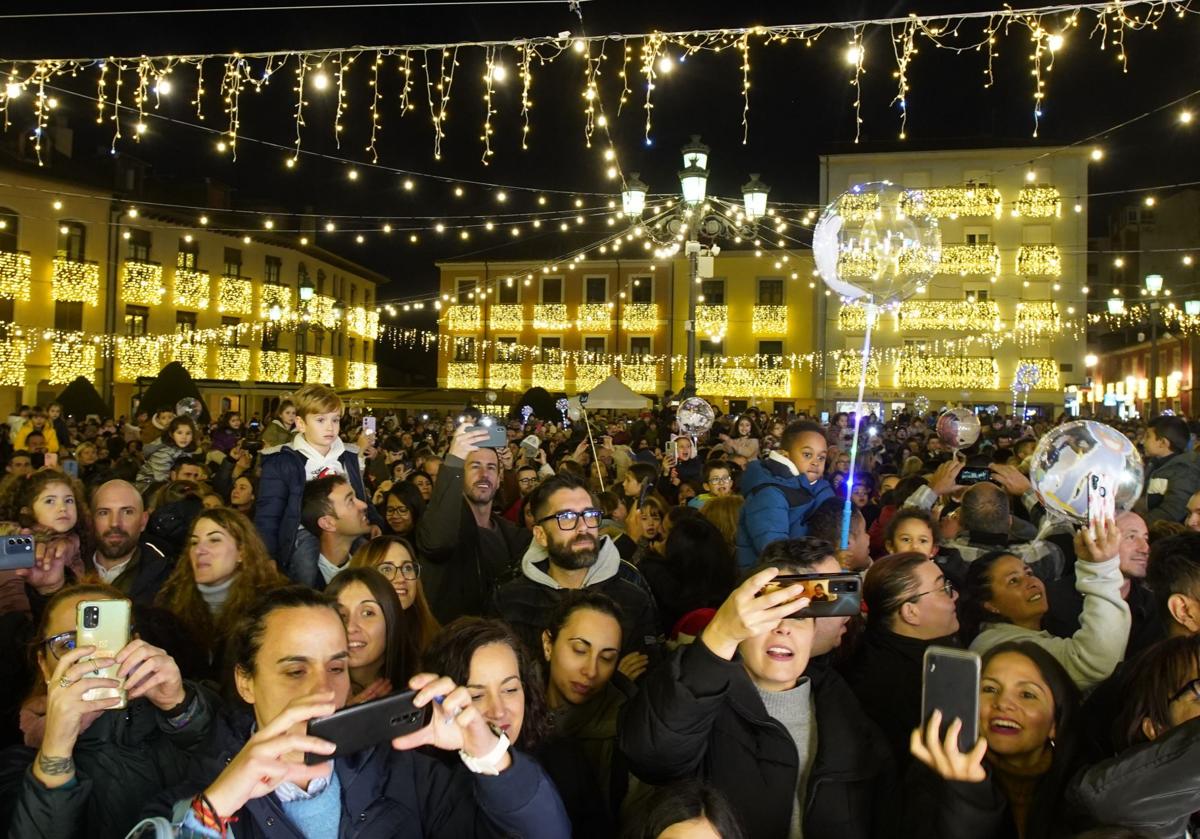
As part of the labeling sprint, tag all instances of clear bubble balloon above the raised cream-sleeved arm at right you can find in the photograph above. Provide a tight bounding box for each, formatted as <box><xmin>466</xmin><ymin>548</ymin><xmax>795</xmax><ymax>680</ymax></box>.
<box><xmin>1030</xmin><ymin>420</ymin><xmax>1145</xmax><ymax>523</ymax></box>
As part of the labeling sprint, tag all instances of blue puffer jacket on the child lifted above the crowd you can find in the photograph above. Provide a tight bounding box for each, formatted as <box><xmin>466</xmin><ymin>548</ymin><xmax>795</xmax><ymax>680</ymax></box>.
<box><xmin>737</xmin><ymin>460</ymin><xmax>833</xmax><ymax>569</ymax></box>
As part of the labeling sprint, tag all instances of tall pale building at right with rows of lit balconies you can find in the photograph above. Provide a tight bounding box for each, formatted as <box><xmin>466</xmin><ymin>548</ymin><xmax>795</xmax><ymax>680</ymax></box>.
<box><xmin>818</xmin><ymin>148</ymin><xmax>1090</xmax><ymax>414</ymax></box>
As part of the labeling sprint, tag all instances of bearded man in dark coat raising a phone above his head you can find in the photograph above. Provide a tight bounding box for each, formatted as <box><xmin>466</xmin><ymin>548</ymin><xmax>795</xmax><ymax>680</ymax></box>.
<box><xmin>416</xmin><ymin>420</ymin><xmax>540</xmax><ymax>631</ymax></box>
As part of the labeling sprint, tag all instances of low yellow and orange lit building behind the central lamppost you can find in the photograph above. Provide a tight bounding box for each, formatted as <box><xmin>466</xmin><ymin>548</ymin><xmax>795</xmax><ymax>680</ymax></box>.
<box><xmin>438</xmin><ymin>251</ymin><xmax>816</xmax><ymax>412</ymax></box>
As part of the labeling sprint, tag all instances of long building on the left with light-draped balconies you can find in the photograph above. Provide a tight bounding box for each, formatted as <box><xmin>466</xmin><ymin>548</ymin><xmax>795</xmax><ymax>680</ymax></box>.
<box><xmin>0</xmin><ymin>165</ymin><xmax>385</xmax><ymax>415</ymax></box>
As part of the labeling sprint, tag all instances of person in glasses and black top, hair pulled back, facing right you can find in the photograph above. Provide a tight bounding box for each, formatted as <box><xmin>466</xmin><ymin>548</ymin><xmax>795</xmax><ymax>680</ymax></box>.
<box><xmin>844</xmin><ymin>553</ymin><xmax>959</xmax><ymax>777</ymax></box>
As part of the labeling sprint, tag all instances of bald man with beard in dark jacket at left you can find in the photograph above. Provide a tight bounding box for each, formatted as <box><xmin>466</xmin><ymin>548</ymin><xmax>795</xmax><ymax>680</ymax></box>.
<box><xmin>90</xmin><ymin>480</ymin><xmax>175</xmax><ymax>606</ymax></box>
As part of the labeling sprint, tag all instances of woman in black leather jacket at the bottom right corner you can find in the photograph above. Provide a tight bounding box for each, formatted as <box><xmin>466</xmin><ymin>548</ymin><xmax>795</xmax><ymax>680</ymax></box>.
<box><xmin>1069</xmin><ymin>635</ymin><xmax>1200</xmax><ymax>837</ymax></box>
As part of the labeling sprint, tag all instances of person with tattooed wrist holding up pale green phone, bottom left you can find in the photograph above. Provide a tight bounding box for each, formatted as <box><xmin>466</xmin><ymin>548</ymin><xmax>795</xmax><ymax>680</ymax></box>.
<box><xmin>0</xmin><ymin>585</ymin><xmax>212</xmax><ymax>839</ymax></box>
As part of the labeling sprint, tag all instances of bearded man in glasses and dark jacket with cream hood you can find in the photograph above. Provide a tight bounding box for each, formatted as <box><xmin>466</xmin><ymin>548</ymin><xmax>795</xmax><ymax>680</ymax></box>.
<box><xmin>489</xmin><ymin>473</ymin><xmax>659</xmax><ymax>677</ymax></box>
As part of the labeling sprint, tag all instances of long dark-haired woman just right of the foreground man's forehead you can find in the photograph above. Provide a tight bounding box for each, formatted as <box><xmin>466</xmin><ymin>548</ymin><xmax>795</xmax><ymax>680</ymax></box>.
<box><xmin>325</xmin><ymin>568</ymin><xmax>418</xmax><ymax>705</ymax></box>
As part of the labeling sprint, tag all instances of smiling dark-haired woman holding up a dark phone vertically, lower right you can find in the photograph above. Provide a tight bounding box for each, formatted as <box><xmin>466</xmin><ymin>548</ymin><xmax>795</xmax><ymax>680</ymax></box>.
<box><xmin>901</xmin><ymin>641</ymin><xmax>1079</xmax><ymax>839</ymax></box>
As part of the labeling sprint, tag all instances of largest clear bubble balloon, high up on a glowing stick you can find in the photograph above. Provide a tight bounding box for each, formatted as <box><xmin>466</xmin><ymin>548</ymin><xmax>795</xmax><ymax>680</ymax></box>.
<box><xmin>812</xmin><ymin>181</ymin><xmax>942</xmax><ymax>306</ymax></box>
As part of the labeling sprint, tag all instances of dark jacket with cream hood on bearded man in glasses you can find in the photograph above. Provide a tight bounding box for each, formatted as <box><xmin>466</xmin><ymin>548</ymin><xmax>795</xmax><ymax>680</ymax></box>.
<box><xmin>492</xmin><ymin>537</ymin><xmax>659</xmax><ymax>661</ymax></box>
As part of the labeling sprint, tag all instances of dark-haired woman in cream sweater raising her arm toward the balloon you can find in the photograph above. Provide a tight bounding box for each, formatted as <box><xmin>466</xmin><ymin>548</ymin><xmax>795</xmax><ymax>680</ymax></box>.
<box><xmin>960</xmin><ymin>519</ymin><xmax>1130</xmax><ymax>690</ymax></box>
